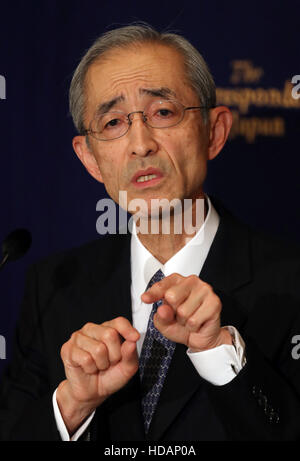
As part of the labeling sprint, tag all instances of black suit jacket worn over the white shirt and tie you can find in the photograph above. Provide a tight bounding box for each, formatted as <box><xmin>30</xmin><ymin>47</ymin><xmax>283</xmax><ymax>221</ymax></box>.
<box><xmin>0</xmin><ymin>202</ymin><xmax>300</xmax><ymax>443</ymax></box>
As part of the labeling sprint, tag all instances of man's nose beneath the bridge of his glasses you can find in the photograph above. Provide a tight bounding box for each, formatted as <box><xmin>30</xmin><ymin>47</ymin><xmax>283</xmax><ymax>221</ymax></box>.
<box><xmin>128</xmin><ymin>112</ymin><xmax>158</xmax><ymax>157</ymax></box>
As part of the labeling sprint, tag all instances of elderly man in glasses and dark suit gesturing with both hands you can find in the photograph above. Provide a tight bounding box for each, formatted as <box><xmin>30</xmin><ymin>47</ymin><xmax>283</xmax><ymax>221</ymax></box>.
<box><xmin>1</xmin><ymin>25</ymin><xmax>300</xmax><ymax>442</ymax></box>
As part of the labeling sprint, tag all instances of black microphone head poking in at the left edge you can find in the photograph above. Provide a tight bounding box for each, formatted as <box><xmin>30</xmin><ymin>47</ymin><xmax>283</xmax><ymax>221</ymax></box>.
<box><xmin>0</xmin><ymin>229</ymin><xmax>32</xmax><ymax>270</ymax></box>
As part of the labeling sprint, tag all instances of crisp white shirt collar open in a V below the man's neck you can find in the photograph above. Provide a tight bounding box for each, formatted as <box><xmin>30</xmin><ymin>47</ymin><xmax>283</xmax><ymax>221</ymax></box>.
<box><xmin>131</xmin><ymin>197</ymin><xmax>220</xmax><ymax>297</ymax></box>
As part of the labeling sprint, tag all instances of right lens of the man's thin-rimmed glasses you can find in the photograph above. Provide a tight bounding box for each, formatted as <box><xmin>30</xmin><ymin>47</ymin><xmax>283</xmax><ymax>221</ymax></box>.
<box><xmin>145</xmin><ymin>100</ymin><xmax>183</xmax><ymax>128</ymax></box>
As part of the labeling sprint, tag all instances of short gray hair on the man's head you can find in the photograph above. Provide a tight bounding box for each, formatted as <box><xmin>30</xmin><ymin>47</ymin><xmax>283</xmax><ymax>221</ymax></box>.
<box><xmin>69</xmin><ymin>23</ymin><xmax>216</xmax><ymax>134</ymax></box>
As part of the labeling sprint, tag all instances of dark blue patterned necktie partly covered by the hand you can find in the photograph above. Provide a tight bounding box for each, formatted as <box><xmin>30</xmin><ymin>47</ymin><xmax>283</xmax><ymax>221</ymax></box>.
<box><xmin>139</xmin><ymin>269</ymin><xmax>176</xmax><ymax>433</ymax></box>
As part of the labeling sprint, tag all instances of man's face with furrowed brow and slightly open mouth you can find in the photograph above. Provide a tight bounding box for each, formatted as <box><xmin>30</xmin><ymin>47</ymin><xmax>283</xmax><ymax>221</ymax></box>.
<box><xmin>77</xmin><ymin>44</ymin><xmax>209</xmax><ymax>208</ymax></box>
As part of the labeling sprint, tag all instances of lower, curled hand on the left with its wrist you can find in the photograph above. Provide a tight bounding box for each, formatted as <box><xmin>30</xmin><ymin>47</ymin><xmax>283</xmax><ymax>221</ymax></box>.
<box><xmin>56</xmin><ymin>317</ymin><xmax>140</xmax><ymax>435</ymax></box>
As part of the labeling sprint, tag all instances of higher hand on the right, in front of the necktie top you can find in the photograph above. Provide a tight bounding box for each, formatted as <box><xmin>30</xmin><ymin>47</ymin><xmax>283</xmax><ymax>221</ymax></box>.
<box><xmin>141</xmin><ymin>274</ymin><xmax>232</xmax><ymax>352</ymax></box>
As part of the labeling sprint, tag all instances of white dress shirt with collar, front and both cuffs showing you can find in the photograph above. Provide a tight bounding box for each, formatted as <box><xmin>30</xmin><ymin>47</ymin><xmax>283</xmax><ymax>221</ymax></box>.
<box><xmin>53</xmin><ymin>197</ymin><xmax>245</xmax><ymax>441</ymax></box>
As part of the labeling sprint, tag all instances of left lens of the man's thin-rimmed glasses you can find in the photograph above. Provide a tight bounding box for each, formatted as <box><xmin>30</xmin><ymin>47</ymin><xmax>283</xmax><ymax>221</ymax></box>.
<box><xmin>91</xmin><ymin>112</ymin><xmax>128</xmax><ymax>140</ymax></box>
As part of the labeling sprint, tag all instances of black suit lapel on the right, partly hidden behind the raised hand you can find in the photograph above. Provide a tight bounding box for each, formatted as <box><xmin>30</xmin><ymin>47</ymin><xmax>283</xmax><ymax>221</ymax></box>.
<box><xmin>147</xmin><ymin>203</ymin><xmax>250</xmax><ymax>440</ymax></box>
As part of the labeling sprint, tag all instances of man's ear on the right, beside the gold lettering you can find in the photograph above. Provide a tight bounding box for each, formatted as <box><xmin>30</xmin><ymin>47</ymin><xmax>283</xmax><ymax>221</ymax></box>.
<box><xmin>208</xmin><ymin>106</ymin><xmax>232</xmax><ymax>160</ymax></box>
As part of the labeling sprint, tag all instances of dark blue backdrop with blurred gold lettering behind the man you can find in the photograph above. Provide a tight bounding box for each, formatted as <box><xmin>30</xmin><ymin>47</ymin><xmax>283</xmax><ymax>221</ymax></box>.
<box><xmin>0</xmin><ymin>0</ymin><xmax>300</xmax><ymax>371</ymax></box>
